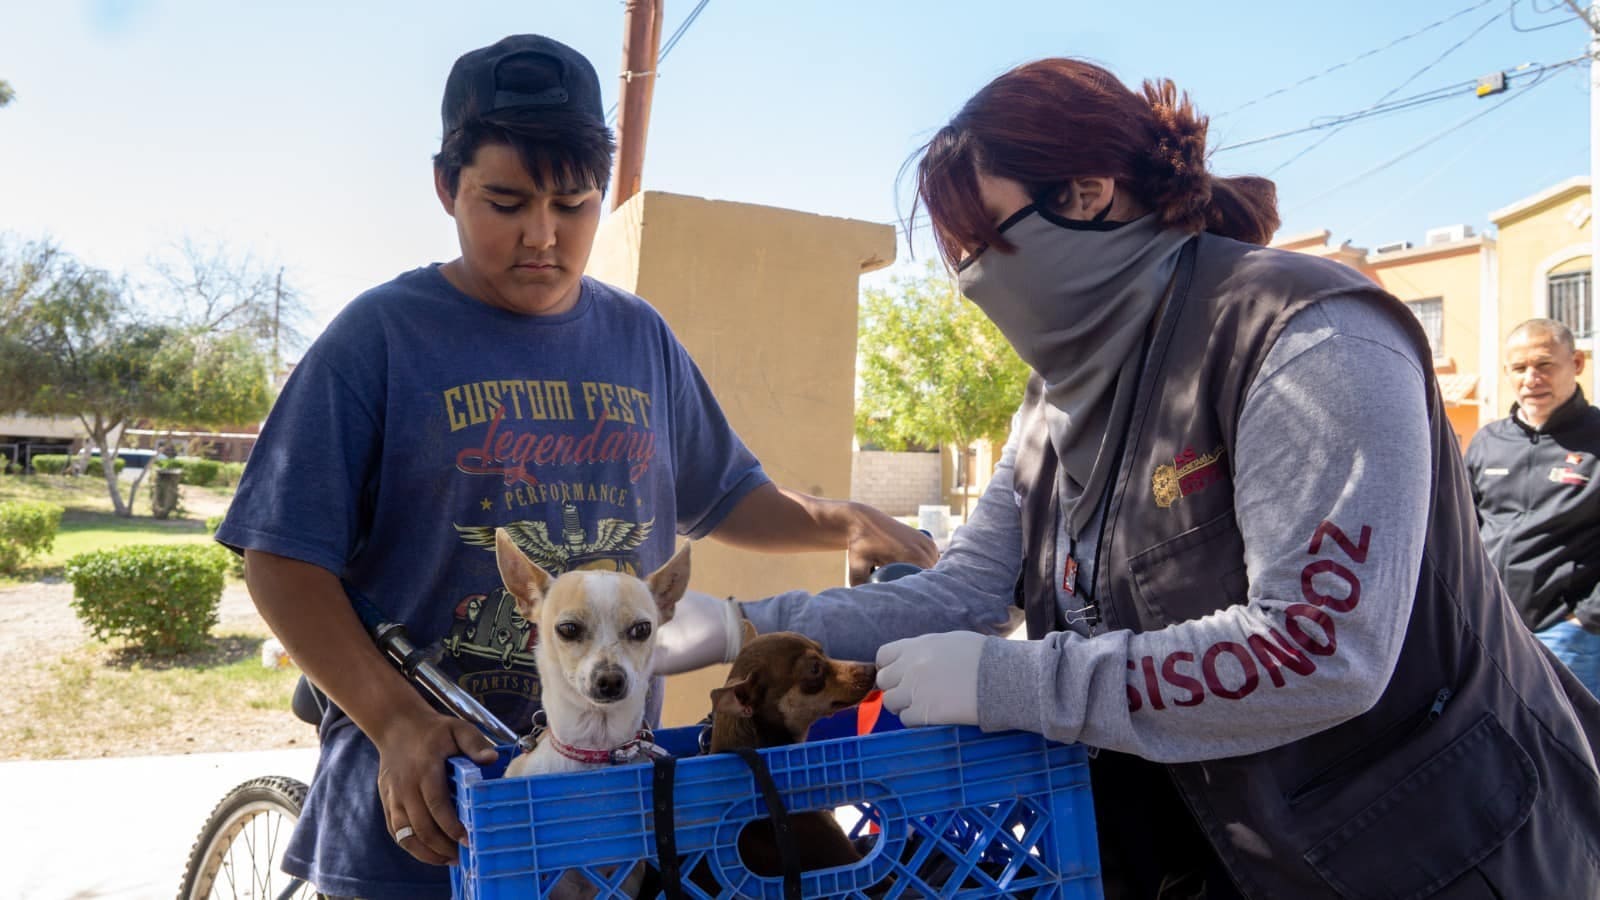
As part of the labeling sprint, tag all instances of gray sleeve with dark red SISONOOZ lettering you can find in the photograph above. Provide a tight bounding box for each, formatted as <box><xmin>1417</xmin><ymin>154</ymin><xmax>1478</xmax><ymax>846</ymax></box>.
<box><xmin>978</xmin><ymin>299</ymin><xmax>1430</xmax><ymax>762</ymax></box>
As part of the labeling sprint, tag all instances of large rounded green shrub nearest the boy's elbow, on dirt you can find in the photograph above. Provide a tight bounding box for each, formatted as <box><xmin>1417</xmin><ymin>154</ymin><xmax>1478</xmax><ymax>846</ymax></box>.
<box><xmin>67</xmin><ymin>544</ymin><xmax>227</xmax><ymax>655</ymax></box>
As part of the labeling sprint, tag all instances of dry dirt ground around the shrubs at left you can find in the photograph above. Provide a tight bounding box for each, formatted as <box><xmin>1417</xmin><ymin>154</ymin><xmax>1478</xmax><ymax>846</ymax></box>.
<box><xmin>0</xmin><ymin>492</ymin><xmax>315</xmax><ymax>756</ymax></box>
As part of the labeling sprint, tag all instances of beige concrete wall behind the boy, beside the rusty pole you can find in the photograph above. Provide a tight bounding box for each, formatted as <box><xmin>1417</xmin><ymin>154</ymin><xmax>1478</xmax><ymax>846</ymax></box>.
<box><xmin>589</xmin><ymin>192</ymin><xmax>894</xmax><ymax>724</ymax></box>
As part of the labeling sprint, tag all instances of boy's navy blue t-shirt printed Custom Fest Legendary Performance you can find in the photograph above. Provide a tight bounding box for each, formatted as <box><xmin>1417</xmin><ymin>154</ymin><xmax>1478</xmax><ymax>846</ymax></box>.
<box><xmin>218</xmin><ymin>266</ymin><xmax>768</xmax><ymax>898</ymax></box>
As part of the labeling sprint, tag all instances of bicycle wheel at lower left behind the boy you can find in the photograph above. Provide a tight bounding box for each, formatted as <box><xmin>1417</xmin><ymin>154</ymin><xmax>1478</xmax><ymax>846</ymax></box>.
<box><xmin>178</xmin><ymin>775</ymin><xmax>317</xmax><ymax>900</ymax></box>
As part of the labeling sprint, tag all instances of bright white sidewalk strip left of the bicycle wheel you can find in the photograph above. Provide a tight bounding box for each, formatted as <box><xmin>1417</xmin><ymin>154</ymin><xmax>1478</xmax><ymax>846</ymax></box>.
<box><xmin>0</xmin><ymin>749</ymin><xmax>317</xmax><ymax>900</ymax></box>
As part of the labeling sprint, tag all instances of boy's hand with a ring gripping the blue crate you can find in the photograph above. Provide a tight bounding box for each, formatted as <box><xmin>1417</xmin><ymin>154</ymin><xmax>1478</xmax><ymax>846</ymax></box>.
<box><xmin>374</xmin><ymin>711</ymin><xmax>498</xmax><ymax>865</ymax></box>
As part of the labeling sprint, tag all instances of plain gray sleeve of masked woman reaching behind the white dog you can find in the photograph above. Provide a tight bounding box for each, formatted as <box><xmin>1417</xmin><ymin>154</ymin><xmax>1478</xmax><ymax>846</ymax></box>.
<box><xmin>744</xmin><ymin>416</ymin><xmax>1022</xmax><ymax>661</ymax></box>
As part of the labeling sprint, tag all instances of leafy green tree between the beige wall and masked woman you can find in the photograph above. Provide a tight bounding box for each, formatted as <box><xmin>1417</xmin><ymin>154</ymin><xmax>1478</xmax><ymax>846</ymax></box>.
<box><xmin>856</xmin><ymin>263</ymin><xmax>1029</xmax><ymax>516</ymax></box>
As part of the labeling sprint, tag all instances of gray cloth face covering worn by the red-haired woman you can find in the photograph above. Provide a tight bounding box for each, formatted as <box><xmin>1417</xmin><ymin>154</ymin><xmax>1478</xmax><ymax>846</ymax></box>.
<box><xmin>958</xmin><ymin>207</ymin><xmax>1192</xmax><ymax>536</ymax></box>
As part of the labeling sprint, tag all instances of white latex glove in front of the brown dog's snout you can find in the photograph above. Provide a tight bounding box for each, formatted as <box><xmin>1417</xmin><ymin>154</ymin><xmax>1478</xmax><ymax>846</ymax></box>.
<box><xmin>877</xmin><ymin>631</ymin><xmax>989</xmax><ymax>725</ymax></box>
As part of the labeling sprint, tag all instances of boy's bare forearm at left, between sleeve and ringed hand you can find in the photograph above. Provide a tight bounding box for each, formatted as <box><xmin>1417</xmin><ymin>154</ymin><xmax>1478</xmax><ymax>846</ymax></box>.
<box><xmin>245</xmin><ymin>551</ymin><xmax>434</xmax><ymax>743</ymax></box>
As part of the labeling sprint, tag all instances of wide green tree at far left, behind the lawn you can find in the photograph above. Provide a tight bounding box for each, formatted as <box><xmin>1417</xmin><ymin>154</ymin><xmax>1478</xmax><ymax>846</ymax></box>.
<box><xmin>0</xmin><ymin>245</ymin><xmax>269</xmax><ymax>516</ymax></box>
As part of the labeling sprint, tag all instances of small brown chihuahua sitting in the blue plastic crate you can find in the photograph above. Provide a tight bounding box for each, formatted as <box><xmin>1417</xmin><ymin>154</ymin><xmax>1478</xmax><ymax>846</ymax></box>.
<box><xmin>710</xmin><ymin>631</ymin><xmax>877</xmax><ymax>878</ymax></box>
